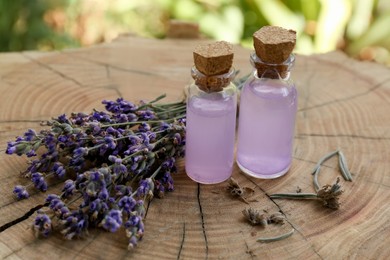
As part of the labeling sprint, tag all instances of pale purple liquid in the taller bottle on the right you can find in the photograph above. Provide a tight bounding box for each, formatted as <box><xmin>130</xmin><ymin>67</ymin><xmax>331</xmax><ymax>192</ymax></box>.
<box><xmin>237</xmin><ymin>75</ymin><xmax>297</xmax><ymax>179</ymax></box>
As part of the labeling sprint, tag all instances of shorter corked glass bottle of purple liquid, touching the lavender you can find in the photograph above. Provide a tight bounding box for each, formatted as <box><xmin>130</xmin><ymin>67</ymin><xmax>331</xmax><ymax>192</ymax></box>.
<box><xmin>185</xmin><ymin>41</ymin><xmax>237</xmax><ymax>184</ymax></box>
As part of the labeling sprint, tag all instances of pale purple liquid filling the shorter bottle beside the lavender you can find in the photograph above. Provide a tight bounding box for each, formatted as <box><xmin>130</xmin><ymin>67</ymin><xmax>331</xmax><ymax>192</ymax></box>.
<box><xmin>185</xmin><ymin>85</ymin><xmax>237</xmax><ymax>184</ymax></box>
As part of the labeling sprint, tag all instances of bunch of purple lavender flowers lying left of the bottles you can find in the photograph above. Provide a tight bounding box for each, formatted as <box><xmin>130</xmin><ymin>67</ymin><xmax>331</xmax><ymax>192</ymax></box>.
<box><xmin>6</xmin><ymin>95</ymin><xmax>186</xmax><ymax>248</ymax></box>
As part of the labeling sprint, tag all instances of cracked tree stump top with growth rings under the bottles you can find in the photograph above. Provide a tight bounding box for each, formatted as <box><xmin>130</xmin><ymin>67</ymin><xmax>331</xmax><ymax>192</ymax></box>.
<box><xmin>0</xmin><ymin>36</ymin><xmax>390</xmax><ymax>259</ymax></box>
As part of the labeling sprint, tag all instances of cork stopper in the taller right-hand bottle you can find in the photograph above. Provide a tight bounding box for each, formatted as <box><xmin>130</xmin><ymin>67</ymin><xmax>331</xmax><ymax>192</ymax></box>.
<box><xmin>253</xmin><ymin>26</ymin><xmax>296</xmax><ymax>79</ymax></box>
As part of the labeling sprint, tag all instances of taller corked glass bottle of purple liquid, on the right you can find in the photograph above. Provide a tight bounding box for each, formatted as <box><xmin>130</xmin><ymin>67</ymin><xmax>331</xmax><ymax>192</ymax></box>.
<box><xmin>237</xmin><ymin>26</ymin><xmax>297</xmax><ymax>179</ymax></box>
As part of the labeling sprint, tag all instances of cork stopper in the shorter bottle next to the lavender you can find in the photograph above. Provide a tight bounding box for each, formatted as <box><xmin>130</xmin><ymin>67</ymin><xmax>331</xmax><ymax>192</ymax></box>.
<box><xmin>192</xmin><ymin>41</ymin><xmax>234</xmax><ymax>92</ymax></box>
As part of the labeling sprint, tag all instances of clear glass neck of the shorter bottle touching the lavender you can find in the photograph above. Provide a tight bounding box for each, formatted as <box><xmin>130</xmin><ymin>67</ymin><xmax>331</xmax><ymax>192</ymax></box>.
<box><xmin>191</xmin><ymin>66</ymin><xmax>236</xmax><ymax>93</ymax></box>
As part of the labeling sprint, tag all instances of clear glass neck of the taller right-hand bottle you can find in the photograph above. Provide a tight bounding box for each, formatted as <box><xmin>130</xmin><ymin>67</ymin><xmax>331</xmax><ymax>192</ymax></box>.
<box><xmin>250</xmin><ymin>53</ymin><xmax>295</xmax><ymax>80</ymax></box>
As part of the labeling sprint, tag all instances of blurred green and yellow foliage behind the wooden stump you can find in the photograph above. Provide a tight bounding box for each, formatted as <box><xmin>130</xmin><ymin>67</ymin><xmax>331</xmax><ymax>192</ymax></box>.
<box><xmin>0</xmin><ymin>0</ymin><xmax>390</xmax><ymax>65</ymax></box>
